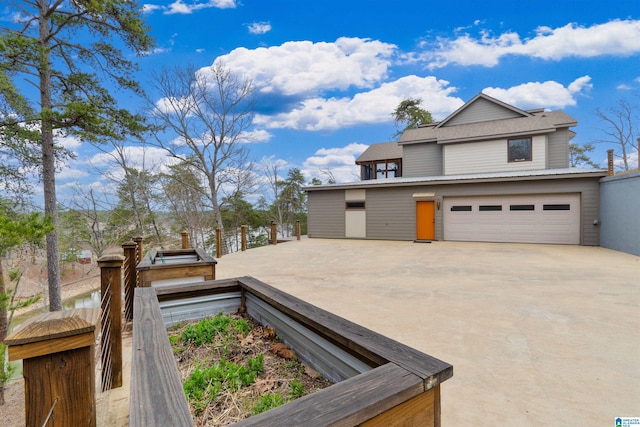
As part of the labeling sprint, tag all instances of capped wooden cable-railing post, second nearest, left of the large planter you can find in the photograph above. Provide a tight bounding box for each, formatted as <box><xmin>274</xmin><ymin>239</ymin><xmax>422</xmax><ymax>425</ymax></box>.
<box><xmin>98</xmin><ymin>255</ymin><xmax>124</xmax><ymax>391</ymax></box>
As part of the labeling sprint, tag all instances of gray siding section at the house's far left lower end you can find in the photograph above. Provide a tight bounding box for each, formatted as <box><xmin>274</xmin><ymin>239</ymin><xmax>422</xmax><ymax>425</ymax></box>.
<box><xmin>307</xmin><ymin>190</ymin><xmax>345</xmax><ymax>239</ymax></box>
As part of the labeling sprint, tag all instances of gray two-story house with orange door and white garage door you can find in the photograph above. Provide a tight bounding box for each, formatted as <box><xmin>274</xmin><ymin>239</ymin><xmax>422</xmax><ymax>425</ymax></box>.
<box><xmin>306</xmin><ymin>93</ymin><xmax>607</xmax><ymax>245</ymax></box>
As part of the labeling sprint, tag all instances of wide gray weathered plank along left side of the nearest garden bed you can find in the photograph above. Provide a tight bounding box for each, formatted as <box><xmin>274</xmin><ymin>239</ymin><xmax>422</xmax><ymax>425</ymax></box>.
<box><xmin>129</xmin><ymin>288</ymin><xmax>193</xmax><ymax>427</ymax></box>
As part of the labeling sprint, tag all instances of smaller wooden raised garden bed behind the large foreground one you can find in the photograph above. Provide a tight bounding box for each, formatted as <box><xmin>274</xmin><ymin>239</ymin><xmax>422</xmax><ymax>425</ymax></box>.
<box><xmin>136</xmin><ymin>248</ymin><xmax>217</xmax><ymax>287</ymax></box>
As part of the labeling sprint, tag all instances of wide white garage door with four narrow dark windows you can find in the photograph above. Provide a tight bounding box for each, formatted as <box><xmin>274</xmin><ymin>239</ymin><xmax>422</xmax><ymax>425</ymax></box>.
<box><xmin>443</xmin><ymin>194</ymin><xmax>580</xmax><ymax>245</ymax></box>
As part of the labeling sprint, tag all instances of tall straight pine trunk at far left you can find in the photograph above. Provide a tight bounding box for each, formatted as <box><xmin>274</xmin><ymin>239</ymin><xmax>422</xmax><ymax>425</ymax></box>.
<box><xmin>38</xmin><ymin>0</ymin><xmax>62</xmax><ymax>311</ymax></box>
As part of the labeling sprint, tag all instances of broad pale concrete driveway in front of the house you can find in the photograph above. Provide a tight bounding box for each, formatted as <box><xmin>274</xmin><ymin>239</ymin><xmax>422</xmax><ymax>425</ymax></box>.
<box><xmin>216</xmin><ymin>239</ymin><xmax>640</xmax><ymax>427</ymax></box>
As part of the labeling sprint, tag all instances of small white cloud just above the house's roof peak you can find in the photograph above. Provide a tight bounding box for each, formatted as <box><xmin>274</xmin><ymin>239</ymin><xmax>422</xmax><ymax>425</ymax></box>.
<box><xmin>482</xmin><ymin>76</ymin><xmax>592</xmax><ymax>108</ymax></box>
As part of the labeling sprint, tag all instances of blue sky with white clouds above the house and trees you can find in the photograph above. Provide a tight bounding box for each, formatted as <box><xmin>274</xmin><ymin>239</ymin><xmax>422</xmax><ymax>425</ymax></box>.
<box><xmin>5</xmin><ymin>0</ymin><xmax>640</xmax><ymax>205</ymax></box>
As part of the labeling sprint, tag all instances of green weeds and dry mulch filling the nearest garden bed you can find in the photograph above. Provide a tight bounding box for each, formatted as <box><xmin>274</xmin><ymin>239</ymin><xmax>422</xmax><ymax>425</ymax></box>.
<box><xmin>169</xmin><ymin>313</ymin><xmax>326</xmax><ymax>422</ymax></box>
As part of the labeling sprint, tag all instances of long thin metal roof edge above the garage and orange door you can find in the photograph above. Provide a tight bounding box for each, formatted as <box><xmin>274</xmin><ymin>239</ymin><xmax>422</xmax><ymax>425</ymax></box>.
<box><xmin>303</xmin><ymin>168</ymin><xmax>607</xmax><ymax>191</ymax></box>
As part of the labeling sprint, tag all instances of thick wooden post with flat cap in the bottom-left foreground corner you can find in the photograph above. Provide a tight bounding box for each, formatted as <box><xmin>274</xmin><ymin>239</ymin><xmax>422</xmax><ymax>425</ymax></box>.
<box><xmin>5</xmin><ymin>308</ymin><xmax>100</xmax><ymax>427</ymax></box>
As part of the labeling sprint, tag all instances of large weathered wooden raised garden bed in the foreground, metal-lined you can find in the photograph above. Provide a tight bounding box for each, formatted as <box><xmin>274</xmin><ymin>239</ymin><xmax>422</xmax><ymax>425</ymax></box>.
<box><xmin>129</xmin><ymin>277</ymin><xmax>453</xmax><ymax>427</ymax></box>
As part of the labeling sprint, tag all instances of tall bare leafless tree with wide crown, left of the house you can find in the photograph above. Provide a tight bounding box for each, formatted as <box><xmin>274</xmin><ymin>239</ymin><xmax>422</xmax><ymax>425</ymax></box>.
<box><xmin>149</xmin><ymin>63</ymin><xmax>254</xmax><ymax>232</ymax></box>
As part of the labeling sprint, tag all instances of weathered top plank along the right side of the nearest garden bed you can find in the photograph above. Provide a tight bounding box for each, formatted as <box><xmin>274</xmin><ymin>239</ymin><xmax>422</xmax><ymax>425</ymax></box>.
<box><xmin>238</xmin><ymin>276</ymin><xmax>453</xmax><ymax>390</ymax></box>
